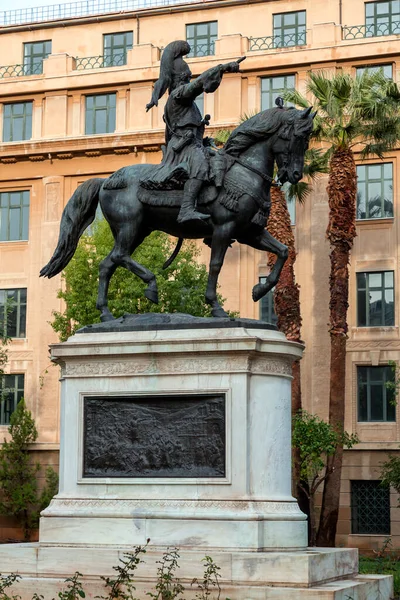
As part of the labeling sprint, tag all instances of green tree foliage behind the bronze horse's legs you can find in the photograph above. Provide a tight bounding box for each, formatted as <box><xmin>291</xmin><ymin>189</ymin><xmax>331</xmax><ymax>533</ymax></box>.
<box><xmin>51</xmin><ymin>219</ymin><xmax>222</xmax><ymax>341</ymax></box>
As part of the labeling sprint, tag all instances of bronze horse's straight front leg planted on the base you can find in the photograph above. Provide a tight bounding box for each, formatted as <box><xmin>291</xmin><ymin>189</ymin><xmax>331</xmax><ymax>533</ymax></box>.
<box><xmin>206</xmin><ymin>223</ymin><xmax>233</xmax><ymax>317</ymax></box>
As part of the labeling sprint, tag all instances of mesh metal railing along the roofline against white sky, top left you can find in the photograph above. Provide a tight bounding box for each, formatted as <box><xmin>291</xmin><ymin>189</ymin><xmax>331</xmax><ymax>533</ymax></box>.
<box><xmin>0</xmin><ymin>0</ymin><xmax>212</xmax><ymax>26</ymax></box>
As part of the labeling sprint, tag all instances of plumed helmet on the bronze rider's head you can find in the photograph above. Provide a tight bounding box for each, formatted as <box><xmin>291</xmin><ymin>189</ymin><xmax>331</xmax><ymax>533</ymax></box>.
<box><xmin>146</xmin><ymin>40</ymin><xmax>192</xmax><ymax>110</ymax></box>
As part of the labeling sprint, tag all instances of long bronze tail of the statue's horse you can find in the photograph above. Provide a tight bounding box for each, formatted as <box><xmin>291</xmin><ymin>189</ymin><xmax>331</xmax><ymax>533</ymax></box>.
<box><xmin>40</xmin><ymin>178</ymin><xmax>104</xmax><ymax>279</ymax></box>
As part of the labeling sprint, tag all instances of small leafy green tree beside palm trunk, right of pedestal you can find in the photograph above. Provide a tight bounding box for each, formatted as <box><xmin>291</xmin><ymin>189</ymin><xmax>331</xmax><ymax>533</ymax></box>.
<box><xmin>292</xmin><ymin>410</ymin><xmax>359</xmax><ymax>546</ymax></box>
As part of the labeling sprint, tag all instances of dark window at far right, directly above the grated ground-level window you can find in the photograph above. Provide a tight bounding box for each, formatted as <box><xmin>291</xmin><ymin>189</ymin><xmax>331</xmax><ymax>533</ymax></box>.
<box><xmin>357</xmin><ymin>366</ymin><xmax>396</xmax><ymax>422</ymax></box>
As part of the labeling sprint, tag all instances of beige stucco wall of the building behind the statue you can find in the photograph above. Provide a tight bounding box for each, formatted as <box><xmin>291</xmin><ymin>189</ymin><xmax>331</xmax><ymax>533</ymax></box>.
<box><xmin>0</xmin><ymin>0</ymin><xmax>400</xmax><ymax>546</ymax></box>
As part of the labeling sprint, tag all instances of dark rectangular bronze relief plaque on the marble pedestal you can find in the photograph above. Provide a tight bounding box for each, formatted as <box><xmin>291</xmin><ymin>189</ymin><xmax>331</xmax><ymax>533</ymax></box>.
<box><xmin>83</xmin><ymin>395</ymin><xmax>226</xmax><ymax>478</ymax></box>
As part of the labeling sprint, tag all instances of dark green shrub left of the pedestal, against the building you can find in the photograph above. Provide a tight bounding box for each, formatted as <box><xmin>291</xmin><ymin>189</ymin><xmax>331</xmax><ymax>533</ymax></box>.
<box><xmin>0</xmin><ymin>400</ymin><xmax>58</xmax><ymax>540</ymax></box>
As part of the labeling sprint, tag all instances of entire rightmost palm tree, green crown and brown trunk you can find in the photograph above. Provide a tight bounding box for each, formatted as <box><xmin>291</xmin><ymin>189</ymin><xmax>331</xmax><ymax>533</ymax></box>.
<box><xmin>285</xmin><ymin>70</ymin><xmax>400</xmax><ymax>546</ymax></box>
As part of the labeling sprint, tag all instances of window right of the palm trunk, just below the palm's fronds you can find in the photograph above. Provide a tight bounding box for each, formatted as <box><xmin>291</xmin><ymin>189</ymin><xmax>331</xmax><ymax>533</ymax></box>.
<box><xmin>357</xmin><ymin>163</ymin><xmax>393</xmax><ymax>219</ymax></box>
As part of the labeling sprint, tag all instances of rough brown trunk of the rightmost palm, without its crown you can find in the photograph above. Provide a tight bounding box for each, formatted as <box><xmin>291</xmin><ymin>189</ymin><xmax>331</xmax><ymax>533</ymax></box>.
<box><xmin>317</xmin><ymin>148</ymin><xmax>357</xmax><ymax>546</ymax></box>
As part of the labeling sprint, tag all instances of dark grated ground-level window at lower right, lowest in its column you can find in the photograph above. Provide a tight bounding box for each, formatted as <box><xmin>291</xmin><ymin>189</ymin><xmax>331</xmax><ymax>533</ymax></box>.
<box><xmin>350</xmin><ymin>479</ymin><xmax>392</xmax><ymax>536</ymax></box>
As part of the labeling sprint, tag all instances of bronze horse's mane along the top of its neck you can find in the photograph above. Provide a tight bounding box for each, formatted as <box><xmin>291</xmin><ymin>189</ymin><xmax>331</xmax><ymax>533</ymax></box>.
<box><xmin>224</xmin><ymin>107</ymin><xmax>300</xmax><ymax>156</ymax></box>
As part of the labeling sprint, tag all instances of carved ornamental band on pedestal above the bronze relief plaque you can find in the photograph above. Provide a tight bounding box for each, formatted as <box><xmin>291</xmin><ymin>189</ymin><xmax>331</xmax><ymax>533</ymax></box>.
<box><xmin>62</xmin><ymin>356</ymin><xmax>292</xmax><ymax>377</ymax></box>
